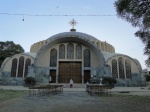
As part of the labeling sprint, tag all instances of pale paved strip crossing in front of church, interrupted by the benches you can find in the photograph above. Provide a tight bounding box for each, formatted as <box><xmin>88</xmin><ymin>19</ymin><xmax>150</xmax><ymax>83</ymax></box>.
<box><xmin>0</xmin><ymin>86</ymin><xmax>150</xmax><ymax>96</ymax></box>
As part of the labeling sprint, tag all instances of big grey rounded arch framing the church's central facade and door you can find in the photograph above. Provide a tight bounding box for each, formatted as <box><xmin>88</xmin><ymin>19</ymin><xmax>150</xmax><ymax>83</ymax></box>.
<box><xmin>34</xmin><ymin>32</ymin><xmax>106</xmax><ymax>67</ymax></box>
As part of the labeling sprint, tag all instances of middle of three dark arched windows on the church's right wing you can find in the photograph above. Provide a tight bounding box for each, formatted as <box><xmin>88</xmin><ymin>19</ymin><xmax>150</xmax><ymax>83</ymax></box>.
<box><xmin>118</xmin><ymin>57</ymin><xmax>125</xmax><ymax>78</ymax></box>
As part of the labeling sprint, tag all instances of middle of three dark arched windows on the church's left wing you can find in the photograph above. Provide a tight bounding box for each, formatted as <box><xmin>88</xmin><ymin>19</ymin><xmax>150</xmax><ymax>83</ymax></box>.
<box><xmin>17</xmin><ymin>56</ymin><xmax>24</xmax><ymax>77</ymax></box>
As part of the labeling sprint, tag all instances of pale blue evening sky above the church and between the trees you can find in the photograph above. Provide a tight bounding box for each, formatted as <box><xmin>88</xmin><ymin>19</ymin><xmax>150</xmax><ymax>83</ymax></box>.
<box><xmin>0</xmin><ymin>0</ymin><xmax>147</xmax><ymax>69</ymax></box>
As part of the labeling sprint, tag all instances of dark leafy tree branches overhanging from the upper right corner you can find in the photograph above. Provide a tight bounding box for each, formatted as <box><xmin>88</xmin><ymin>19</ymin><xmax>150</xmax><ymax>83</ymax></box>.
<box><xmin>114</xmin><ymin>0</ymin><xmax>150</xmax><ymax>65</ymax></box>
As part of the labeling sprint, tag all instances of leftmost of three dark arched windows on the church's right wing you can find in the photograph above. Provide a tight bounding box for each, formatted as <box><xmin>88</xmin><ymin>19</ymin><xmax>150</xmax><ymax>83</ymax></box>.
<box><xmin>111</xmin><ymin>59</ymin><xmax>118</xmax><ymax>78</ymax></box>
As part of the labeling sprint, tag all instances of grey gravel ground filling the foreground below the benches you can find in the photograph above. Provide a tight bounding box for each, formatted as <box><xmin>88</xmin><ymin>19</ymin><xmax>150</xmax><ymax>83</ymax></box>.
<box><xmin>0</xmin><ymin>92</ymin><xmax>150</xmax><ymax>112</ymax></box>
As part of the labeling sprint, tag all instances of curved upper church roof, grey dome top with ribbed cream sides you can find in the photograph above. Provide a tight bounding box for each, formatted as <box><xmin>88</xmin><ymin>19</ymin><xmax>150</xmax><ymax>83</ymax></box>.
<box><xmin>30</xmin><ymin>32</ymin><xmax>115</xmax><ymax>52</ymax></box>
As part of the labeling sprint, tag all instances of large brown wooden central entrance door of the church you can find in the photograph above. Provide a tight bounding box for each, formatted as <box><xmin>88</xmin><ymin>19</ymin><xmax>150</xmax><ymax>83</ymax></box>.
<box><xmin>58</xmin><ymin>62</ymin><xmax>82</xmax><ymax>83</ymax></box>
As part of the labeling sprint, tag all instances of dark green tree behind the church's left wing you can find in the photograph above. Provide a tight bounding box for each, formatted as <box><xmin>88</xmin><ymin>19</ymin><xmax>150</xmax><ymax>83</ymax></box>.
<box><xmin>0</xmin><ymin>41</ymin><xmax>24</xmax><ymax>66</ymax></box>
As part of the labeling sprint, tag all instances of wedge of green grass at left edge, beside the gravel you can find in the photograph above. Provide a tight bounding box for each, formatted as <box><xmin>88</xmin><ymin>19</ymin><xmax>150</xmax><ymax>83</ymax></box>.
<box><xmin>0</xmin><ymin>89</ymin><xmax>28</xmax><ymax>102</ymax></box>
